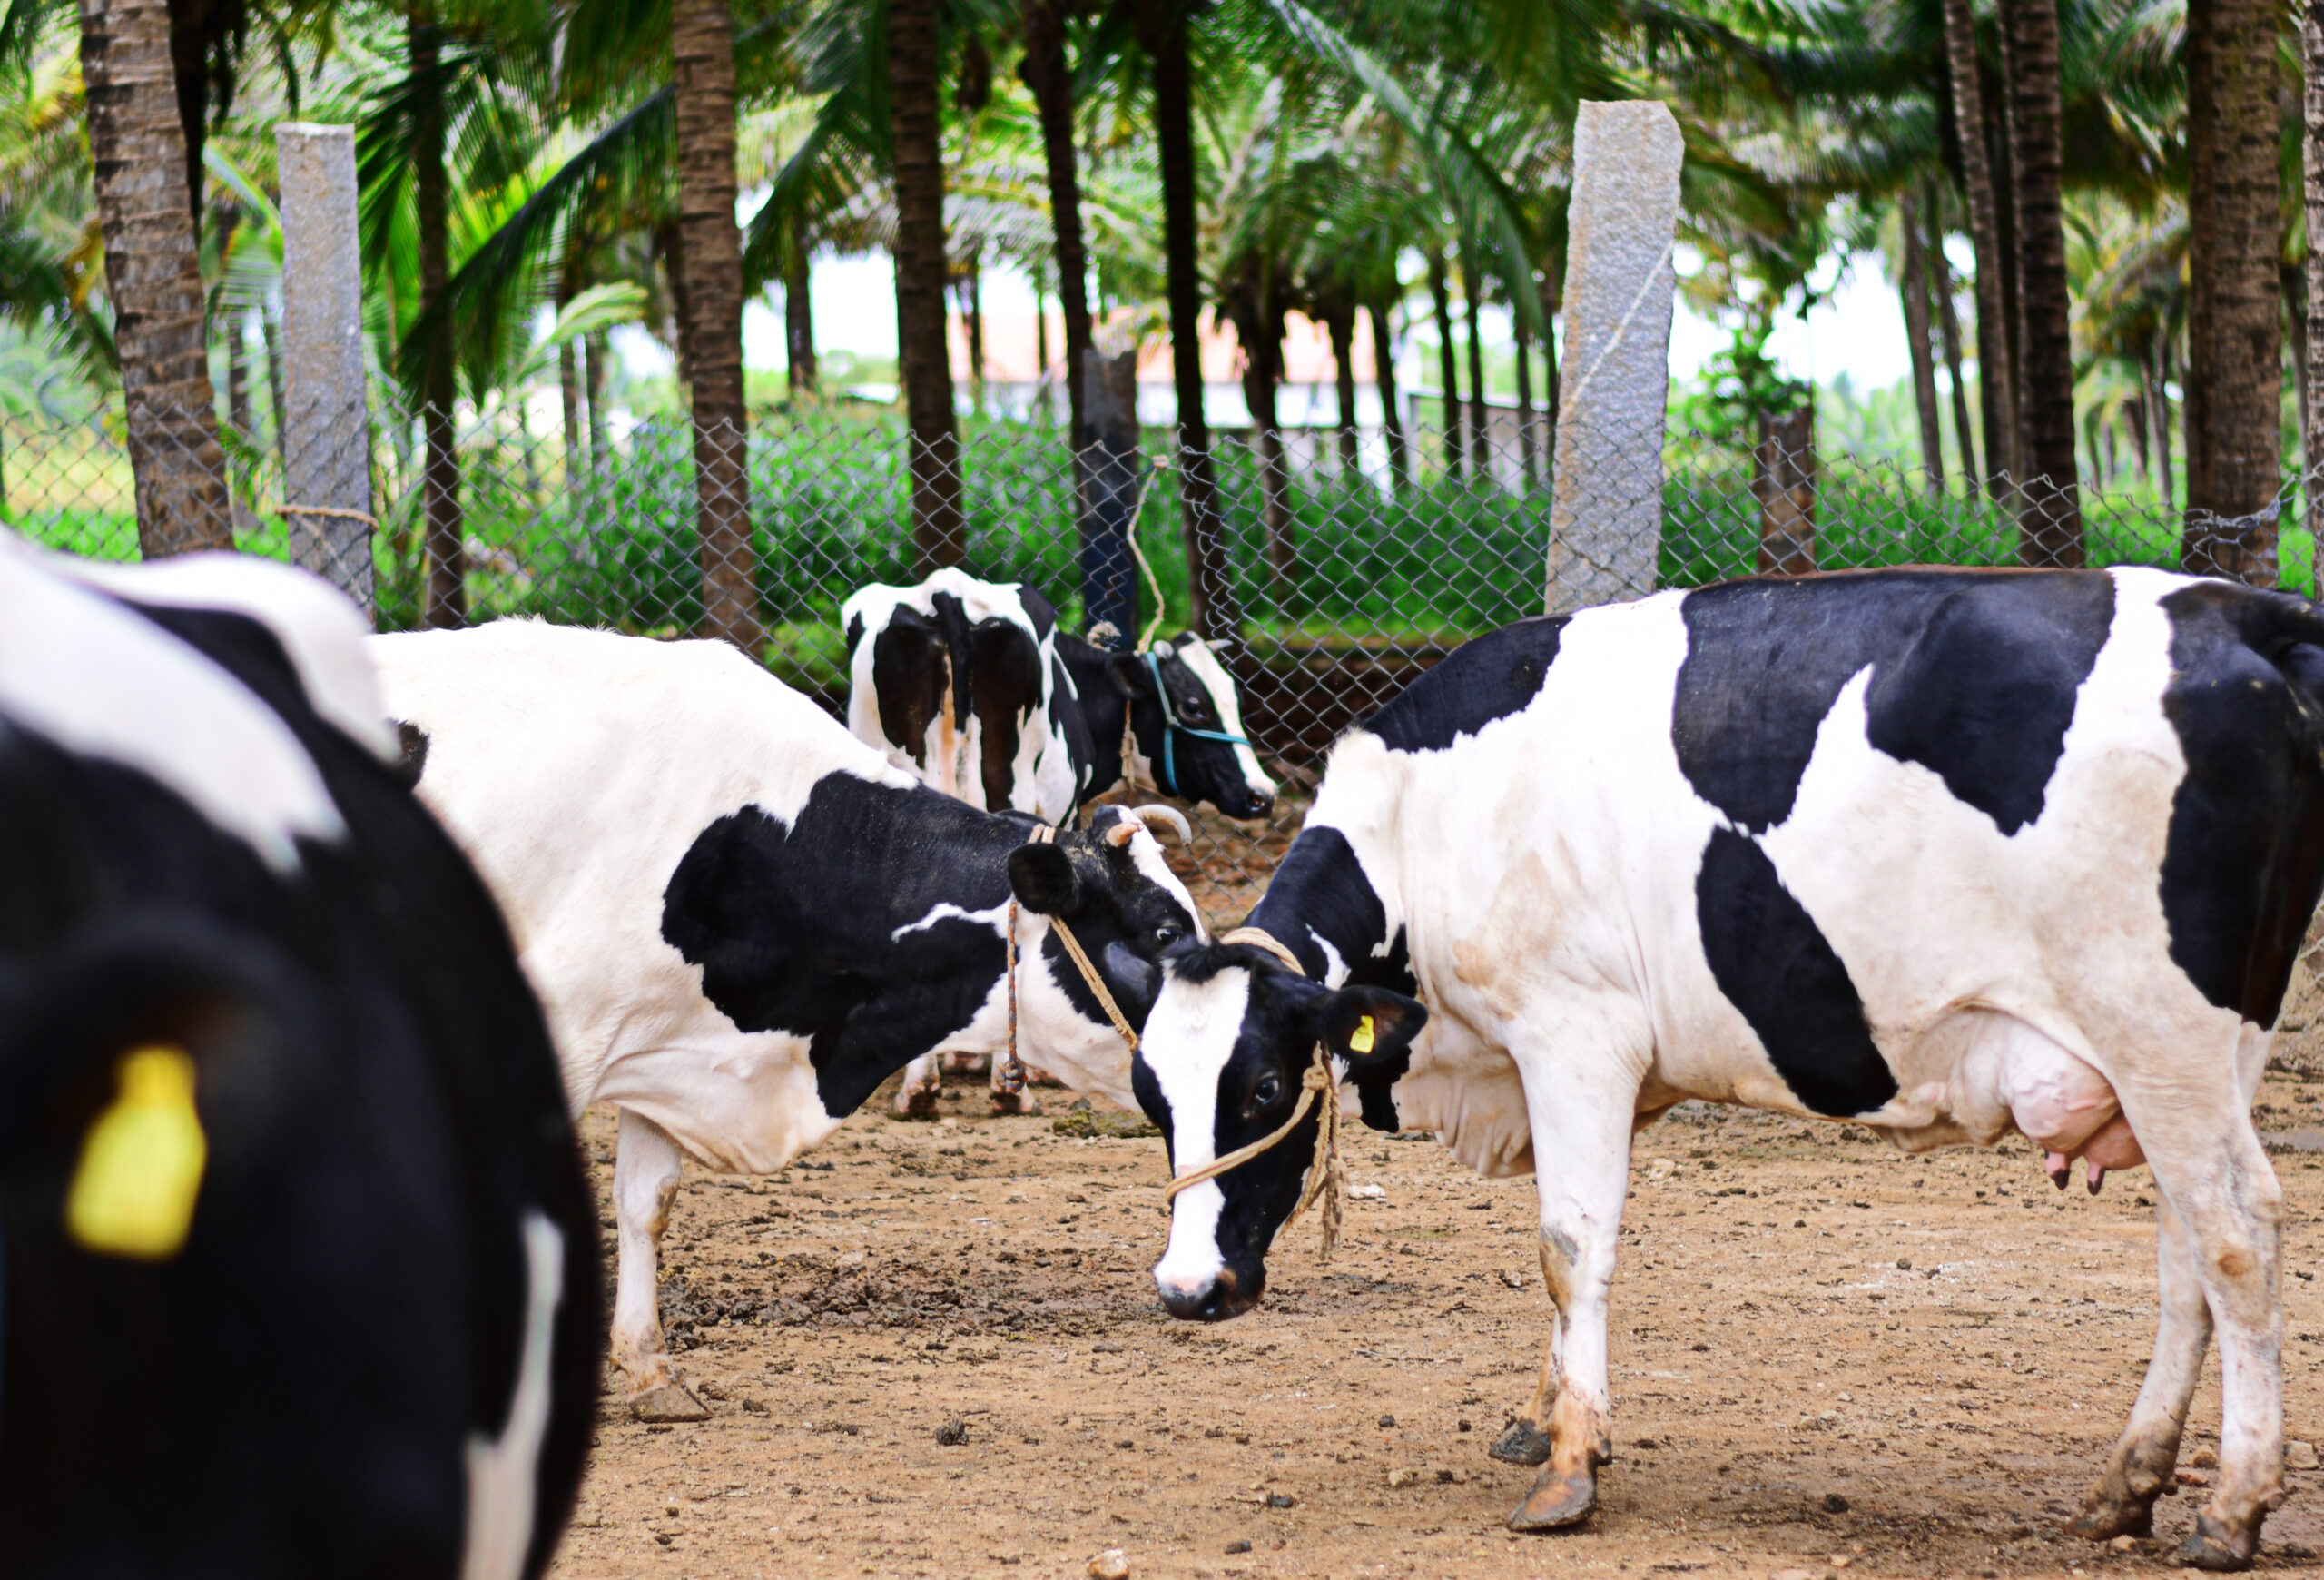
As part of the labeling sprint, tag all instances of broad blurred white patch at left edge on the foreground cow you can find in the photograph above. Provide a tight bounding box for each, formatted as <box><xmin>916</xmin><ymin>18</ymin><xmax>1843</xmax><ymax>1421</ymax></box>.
<box><xmin>0</xmin><ymin>537</ymin><xmax>346</xmax><ymax>872</ymax></box>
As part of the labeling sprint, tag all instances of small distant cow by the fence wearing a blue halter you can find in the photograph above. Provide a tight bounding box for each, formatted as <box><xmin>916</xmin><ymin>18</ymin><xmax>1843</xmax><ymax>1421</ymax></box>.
<box><xmin>839</xmin><ymin>569</ymin><xmax>1275</xmax><ymax>823</ymax></box>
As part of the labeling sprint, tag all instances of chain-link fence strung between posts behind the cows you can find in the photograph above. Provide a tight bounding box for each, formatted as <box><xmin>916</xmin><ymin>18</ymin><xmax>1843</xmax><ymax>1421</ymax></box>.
<box><xmin>0</xmin><ymin>398</ymin><xmax>2315</xmax><ymax>923</ymax></box>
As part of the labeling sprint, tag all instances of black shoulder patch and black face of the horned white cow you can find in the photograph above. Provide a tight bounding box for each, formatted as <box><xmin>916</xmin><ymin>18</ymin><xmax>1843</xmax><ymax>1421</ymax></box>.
<box><xmin>663</xmin><ymin>774</ymin><xmax>1192</xmax><ymax>1115</ymax></box>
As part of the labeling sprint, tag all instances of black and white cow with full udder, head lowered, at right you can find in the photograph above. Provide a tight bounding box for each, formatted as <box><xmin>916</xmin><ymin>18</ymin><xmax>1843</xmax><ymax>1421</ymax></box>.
<box><xmin>1137</xmin><ymin>569</ymin><xmax>2324</xmax><ymax>1568</ymax></box>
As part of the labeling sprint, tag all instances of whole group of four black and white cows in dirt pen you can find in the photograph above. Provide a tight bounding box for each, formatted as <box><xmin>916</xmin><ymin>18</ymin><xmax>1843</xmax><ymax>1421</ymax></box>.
<box><xmin>0</xmin><ymin>535</ymin><xmax>2324</xmax><ymax>1580</ymax></box>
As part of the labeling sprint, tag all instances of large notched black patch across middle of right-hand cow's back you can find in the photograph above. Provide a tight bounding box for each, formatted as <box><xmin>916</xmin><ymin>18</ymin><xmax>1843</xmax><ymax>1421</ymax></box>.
<box><xmin>1671</xmin><ymin>571</ymin><xmax>2115</xmax><ymax>834</ymax></box>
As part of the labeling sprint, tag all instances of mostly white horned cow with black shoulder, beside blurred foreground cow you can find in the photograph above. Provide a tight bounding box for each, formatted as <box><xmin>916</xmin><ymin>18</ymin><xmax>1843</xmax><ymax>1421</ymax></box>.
<box><xmin>372</xmin><ymin>620</ymin><xmax>1202</xmax><ymax>1419</ymax></box>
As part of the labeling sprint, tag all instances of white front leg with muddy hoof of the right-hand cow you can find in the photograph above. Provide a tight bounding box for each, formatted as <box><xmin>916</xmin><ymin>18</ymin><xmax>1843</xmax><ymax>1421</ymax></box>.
<box><xmin>1508</xmin><ymin>1062</ymin><xmax>1630</xmax><ymax>1531</ymax></box>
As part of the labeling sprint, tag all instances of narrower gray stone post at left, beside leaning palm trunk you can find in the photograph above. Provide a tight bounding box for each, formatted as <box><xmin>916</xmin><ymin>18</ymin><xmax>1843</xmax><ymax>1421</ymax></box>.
<box><xmin>274</xmin><ymin>121</ymin><xmax>377</xmax><ymax>614</ymax></box>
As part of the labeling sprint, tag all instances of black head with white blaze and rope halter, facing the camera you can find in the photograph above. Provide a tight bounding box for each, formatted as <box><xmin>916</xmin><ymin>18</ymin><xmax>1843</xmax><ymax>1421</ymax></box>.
<box><xmin>1132</xmin><ymin>943</ymin><xmax>1429</xmax><ymax>1322</ymax></box>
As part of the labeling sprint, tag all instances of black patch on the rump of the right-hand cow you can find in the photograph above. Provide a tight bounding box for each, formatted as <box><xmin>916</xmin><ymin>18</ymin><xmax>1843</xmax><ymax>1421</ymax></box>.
<box><xmin>2162</xmin><ymin>583</ymin><xmax>2324</xmax><ymax>1027</ymax></box>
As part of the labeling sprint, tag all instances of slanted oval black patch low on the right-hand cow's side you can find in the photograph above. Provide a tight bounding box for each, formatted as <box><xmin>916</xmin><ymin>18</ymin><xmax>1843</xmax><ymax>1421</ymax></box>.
<box><xmin>1694</xmin><ymin>830</ymin><xmax>1896</xmax><ymax>1115</ymax></box>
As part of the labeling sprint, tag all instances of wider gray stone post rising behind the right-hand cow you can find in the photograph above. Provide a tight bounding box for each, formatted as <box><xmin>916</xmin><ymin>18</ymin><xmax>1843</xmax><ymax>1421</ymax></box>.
<box><xmin>1548</xmin><ymin>100</ymin><xmax>1685</xmax><ymax>614</ymax></box>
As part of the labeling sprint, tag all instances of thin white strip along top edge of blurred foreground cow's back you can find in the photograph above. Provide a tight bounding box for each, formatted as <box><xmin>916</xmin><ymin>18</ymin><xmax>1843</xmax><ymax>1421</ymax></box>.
<box><xmin>49</xmin><ymin>553</ymin><xmax>398</xmax><ymax>762</ymax></box>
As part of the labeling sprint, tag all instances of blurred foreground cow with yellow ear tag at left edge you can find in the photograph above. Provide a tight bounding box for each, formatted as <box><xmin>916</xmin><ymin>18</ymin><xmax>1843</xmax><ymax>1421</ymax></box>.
<box><xmin>0</xmin><ymin>535</ymin><xmax>599</xmax><ymax>1580</ymax></box>
